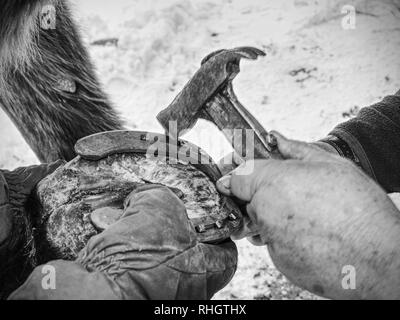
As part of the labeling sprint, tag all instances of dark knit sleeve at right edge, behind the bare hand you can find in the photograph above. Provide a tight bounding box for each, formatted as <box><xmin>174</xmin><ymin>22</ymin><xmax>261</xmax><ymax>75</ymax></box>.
<box><xmin>328</xmin><ymin>91</ymin><xmax>400</xmax><ymax>192</ymax></box>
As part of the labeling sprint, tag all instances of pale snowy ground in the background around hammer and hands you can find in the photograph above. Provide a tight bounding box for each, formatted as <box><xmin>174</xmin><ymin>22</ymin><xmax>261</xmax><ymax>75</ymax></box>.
<box><xmin>0</xmin><ymin>0</ymin><xmax>400</xmax><ymax>299</ymax></box>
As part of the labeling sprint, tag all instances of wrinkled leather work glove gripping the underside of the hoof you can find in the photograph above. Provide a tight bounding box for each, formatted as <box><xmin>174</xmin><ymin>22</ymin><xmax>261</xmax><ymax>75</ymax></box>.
<box><xmin>10</xmin><ymin>185</ymin><xmax>237</xmax><ymax>300</ymax></box>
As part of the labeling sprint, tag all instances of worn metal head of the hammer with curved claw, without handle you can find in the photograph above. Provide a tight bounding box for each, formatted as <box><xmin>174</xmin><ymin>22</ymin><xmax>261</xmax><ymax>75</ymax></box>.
<box><xmin>157</xmin><ymin>47</ymin><xmax>265</xmax><ymax>137</ymax></box>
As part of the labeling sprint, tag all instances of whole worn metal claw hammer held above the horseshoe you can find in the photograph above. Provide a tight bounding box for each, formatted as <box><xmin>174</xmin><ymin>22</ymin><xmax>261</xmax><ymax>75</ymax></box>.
<box><xmin>157</xmin><ymin>47</ymin><xmax>276</xmax><ymax>159</ymax></box>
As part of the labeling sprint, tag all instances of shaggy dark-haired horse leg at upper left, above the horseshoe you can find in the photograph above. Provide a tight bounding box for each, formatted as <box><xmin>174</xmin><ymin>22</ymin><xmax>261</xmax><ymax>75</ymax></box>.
<box><xmin>0</xmin><ymin>0</ymin><xmax>123</xmax><ymax>162</ymax></box>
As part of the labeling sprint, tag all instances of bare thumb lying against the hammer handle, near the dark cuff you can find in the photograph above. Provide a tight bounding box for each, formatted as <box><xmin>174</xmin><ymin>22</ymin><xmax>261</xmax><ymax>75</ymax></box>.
<box><xmin>270</xmin><ymin>131</ymin><xmax>329</xmax><ymax>161</ymax></box>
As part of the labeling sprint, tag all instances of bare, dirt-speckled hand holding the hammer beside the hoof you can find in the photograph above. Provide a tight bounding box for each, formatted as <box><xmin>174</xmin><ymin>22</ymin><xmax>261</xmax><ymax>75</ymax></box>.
<box><xmin>218</xmin><ymin>133</ymin><xmax>400</xmax><ymax>298</ymax></box>
